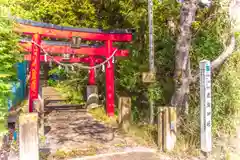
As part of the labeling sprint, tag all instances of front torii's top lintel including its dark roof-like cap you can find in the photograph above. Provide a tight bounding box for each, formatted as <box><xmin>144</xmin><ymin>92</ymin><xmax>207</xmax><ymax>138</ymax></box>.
<box><xmin>15</xmin><ymin>18</ymin><xmax>134</xmax><ymax>42</ymax></box>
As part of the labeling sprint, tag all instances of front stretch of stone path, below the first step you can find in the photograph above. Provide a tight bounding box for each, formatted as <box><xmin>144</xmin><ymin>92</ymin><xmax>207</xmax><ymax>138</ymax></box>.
<box><xmin>45</xmin><ymin>109</ymin><xmax>142</xmax><ymax>151</ymax></box>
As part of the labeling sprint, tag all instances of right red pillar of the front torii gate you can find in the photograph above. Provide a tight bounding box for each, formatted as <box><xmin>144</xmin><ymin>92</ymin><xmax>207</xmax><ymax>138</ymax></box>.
<box><xmin>105</xmin><ymin>40</ymin><xmax>115</xmax><ymax>117</ymax></box>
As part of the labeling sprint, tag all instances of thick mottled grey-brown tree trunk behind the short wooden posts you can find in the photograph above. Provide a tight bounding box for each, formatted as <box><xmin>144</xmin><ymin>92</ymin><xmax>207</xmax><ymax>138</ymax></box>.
<box><xmin>171</xmin><ymin>0</ymin><xmax>198</xmax><ymax>114</ymax></box>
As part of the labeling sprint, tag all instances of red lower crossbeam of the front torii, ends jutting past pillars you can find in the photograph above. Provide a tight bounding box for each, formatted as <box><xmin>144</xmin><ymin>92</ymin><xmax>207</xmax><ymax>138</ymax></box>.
<box><xmin>19</xmin><ymin>42</ymin><xmax>129</xmax><ymax>57</ymax></box>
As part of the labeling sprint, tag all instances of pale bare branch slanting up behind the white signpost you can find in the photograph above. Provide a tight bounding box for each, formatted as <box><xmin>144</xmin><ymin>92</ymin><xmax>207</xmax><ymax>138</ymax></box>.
<box><xmin>191</xmin><ymin>36</ymin><xmax>236</xmax><ymax>83</ymax></box>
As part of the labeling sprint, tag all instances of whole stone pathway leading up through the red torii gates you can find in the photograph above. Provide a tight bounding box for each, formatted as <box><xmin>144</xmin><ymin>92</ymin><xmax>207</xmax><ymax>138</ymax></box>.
<box><xmin>41</xmin><ymin>87</ymin><xmax>159</xmax><ymax>160</ymax></box>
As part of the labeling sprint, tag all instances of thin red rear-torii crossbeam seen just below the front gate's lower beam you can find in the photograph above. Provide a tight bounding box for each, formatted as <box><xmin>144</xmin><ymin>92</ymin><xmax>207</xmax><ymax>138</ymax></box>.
<box><xmin>24</xmin><ymin>54</ymin><xmax>104</xmax><ymax>64</ymax></box>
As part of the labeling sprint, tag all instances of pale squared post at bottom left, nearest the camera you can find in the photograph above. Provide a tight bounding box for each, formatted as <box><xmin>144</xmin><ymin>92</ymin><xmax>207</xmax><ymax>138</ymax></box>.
<box><xmin>19</xmin><ymin>113</ymin><xmax>39</xmax><ymax>160</ymax></box>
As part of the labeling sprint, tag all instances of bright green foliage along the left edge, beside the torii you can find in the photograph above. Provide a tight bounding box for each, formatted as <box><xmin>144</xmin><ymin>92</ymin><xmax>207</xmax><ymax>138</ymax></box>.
<box><xmin>0</xmin><ymin>5</ymin><xmax>21</xmax><ymax>132</ymax></box>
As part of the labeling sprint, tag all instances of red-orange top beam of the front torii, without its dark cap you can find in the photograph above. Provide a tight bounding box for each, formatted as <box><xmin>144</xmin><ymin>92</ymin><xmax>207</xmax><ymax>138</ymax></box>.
<box><xmin>14</xmin><ymin>24</ymin><xmax>132</xmax><ymax>42</ymax></box>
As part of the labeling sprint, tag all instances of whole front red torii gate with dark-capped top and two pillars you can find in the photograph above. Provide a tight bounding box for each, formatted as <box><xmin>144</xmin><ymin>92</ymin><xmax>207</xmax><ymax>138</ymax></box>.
<box><xmin>14</xmin><ymin>19</ymin><xmax>132</xmax><ymax>116</ymax></box>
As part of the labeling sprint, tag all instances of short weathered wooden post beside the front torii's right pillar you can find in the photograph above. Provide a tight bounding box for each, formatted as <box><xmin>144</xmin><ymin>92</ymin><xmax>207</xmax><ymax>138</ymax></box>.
<box><xmin>118</xmin><ymin>97</ymin><xmax>132</xmax><ymax>131</ymax></box>
